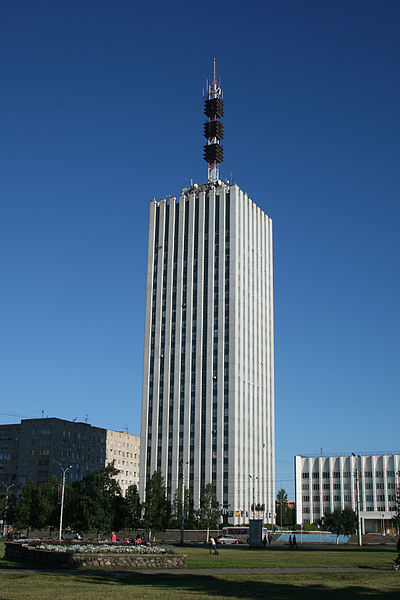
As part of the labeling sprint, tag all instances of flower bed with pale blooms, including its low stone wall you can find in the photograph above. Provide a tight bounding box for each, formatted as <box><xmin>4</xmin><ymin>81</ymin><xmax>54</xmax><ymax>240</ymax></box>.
<box><xmin>5</xmin><ymin>540</ymin><xmax>186</xmax><ymax>569</ymax></box>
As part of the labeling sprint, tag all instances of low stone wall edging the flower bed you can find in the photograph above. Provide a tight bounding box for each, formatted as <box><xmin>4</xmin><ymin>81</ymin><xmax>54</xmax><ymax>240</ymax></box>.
<box><xmin>4</xmin><ymin>542</ymin><xmax>186</xmax><ymax>569</ymax></box>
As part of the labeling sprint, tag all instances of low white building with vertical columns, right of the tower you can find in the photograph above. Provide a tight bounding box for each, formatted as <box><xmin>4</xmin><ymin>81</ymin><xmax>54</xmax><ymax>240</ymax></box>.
<box><xmin>295</xmin><ymin>452</ymin><xmax>400</xmax><ymax>533</ymax></box>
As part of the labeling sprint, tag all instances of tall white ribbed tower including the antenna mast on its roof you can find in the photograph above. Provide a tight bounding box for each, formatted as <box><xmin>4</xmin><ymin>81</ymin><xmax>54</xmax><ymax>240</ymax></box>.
<box><xmin>140</xmin><ymin>62</ymin><xmax>275</xmax><ymax>523</ymax></box>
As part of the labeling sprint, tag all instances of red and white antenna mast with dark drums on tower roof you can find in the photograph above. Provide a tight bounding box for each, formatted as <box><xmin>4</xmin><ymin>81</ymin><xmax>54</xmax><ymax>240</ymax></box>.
<box><xmin>204</xmin><ymin>58</ymin><xmax>224</xmax><ymax>183</ymax></box>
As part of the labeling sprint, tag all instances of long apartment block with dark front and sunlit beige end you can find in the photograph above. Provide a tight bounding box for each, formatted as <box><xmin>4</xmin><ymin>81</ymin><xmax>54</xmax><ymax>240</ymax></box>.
<box><xmin>0</xmin><ymin>417</ymin><xmax>140</xmax><ymax>493</ymax></box>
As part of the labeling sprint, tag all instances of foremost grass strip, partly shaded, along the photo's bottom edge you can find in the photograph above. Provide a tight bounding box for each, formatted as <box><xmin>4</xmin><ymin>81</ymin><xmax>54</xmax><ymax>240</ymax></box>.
<box><xmin>0</xmin><ymin>571</ymin><xmax>400</xmax><ymax>600</ymax></box>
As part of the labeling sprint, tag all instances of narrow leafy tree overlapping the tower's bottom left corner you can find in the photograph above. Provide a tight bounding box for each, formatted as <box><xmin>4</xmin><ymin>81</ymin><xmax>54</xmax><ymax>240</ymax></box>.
<box><xmin>143</xmin><ymin>471</ymin><xmax>171</xmax><ymax>537</ymax></box>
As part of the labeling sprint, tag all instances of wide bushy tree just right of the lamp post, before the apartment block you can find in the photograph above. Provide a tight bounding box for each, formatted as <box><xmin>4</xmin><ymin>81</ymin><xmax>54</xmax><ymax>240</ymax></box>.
<box><xmin>65</xmin><ymin>463</ymin><xmax>122</xmax><ymax>535</ymax></box>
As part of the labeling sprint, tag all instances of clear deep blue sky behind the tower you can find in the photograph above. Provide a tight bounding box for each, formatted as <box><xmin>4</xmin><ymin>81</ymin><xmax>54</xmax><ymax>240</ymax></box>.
<box><xmin>0</xmin><ymin>0</ymin><xmax>400</xmax><ymax>495</ymax></box>
